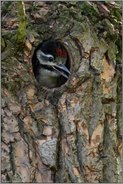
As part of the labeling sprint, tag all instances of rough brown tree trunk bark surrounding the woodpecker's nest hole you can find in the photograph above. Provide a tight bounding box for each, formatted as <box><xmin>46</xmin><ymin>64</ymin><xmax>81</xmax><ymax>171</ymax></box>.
<box><xmin>1</xmin><ymin>1</ymin><xmax>122</xmax><ymax>183</ymax></box>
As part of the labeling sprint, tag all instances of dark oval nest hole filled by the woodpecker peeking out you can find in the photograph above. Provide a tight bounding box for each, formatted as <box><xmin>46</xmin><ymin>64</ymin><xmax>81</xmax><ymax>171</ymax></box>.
<box><xmin>32</xmin><ymin>40</ymin><xmax>70</xmax><ymax>88</ymax></box>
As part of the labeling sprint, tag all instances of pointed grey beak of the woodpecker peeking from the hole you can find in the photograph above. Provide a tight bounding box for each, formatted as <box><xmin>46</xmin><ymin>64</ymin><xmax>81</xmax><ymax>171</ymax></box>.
<box><xmin>53</xmin><ymin>64</ymin><xmax>70</xmax><ymax>79</ymax></box>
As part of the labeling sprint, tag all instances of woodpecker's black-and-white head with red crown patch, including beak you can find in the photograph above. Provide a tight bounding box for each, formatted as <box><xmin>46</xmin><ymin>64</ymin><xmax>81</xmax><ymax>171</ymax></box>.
<box><xmin>36</xmin><ymin>42</ymin><xmax>70</xmax><ymax>79</ymax></box>
